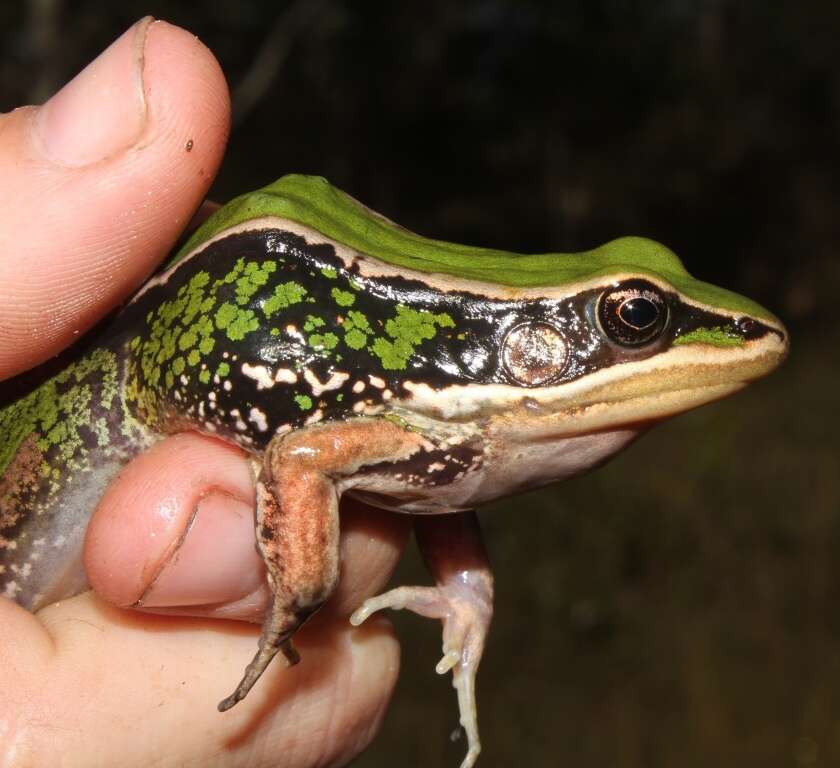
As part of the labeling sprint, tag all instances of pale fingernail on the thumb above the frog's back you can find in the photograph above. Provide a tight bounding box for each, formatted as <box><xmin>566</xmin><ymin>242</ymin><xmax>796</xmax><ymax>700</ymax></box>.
<box><xmin>35</xmin><ymin>17</ymin><xmax>154</xmax><ymax>166</ymax></box>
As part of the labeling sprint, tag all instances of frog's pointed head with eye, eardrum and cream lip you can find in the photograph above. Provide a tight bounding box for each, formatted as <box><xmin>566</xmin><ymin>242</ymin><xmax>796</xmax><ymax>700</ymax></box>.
<box><xmin>390</xmin><ymin>237</ymin><xmax>788</xmax><ymax>440</ymax></box>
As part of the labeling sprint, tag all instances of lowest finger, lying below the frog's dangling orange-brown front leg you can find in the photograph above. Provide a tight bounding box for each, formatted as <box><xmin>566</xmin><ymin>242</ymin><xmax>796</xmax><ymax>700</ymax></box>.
<box><xmin>0</xmin><ymin>593</ymin><xmax>398</xmax><ymax>768</ymax></box>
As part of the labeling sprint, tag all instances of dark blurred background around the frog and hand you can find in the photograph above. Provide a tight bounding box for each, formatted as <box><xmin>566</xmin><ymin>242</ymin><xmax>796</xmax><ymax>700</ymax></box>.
<box><xmin>0</xmin><ymin>0</ymin><xmax>840</xmax><ymax>768</ymax></box>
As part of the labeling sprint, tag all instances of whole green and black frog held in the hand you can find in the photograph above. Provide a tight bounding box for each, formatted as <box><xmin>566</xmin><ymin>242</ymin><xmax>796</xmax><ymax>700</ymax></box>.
<box><xmin>0</xmin><ymin>174</ymin><xmax>789</xmax><ymax>768</ymax></box>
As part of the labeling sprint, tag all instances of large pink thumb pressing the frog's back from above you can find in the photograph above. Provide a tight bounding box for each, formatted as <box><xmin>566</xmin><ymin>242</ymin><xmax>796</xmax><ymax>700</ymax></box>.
<box><xmin>0</xmin><ymin>19</ymin><xmax>229</xmax><ymax>378</ymax></box>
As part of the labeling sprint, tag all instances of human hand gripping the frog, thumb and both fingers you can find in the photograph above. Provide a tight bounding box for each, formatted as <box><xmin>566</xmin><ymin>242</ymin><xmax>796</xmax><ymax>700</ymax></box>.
<box><xmin>0</xmin><ymin>19</ymin><xmax>407</xmax><ymax>768</ymax></box>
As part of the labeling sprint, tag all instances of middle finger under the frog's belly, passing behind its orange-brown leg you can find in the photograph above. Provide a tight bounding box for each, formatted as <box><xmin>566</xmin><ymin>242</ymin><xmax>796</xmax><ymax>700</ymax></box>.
<box><xmin>85</xmin><ymin>433</ymin><xmax>409</xmax><ymax>621</ymax></box>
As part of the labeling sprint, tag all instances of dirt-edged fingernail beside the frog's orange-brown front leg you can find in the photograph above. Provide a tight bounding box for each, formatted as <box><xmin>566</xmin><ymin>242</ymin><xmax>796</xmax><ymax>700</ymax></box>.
<box><xmin>137</xmin><ymin>492</ymin><xmax>265</xmax><ymax>608</ymax></box>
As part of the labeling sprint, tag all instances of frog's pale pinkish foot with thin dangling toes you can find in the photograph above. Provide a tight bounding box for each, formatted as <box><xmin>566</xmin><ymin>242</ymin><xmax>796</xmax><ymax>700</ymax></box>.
<box><xmin>350</xmin><ymin>570</ymin><xmax>493</xmax><ymax>768</ymax></box>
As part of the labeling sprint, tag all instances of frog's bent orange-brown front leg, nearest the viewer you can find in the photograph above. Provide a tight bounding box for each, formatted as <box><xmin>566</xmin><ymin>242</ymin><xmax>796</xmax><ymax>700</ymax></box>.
<box><xmin>219</xmin><ymin>418</ymin><xmax>424</xmax><ymax>712</ymax></box>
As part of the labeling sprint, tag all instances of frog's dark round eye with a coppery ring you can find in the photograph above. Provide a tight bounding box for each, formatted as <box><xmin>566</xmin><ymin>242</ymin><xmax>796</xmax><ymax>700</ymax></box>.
<box><xmin>598</xmin><ymin>280</ymin><xmax>668</xmax><ymax>347</ymax></box>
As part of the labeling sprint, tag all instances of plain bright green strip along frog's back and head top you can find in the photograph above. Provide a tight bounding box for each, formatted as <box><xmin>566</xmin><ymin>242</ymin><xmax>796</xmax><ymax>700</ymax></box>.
<box><xmin>176</xmin><ymin>175</ymin><xmax>775</xmax><ymax>320</ymax></box>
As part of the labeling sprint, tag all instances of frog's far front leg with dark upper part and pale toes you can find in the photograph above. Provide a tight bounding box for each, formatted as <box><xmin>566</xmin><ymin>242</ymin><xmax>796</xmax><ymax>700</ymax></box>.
<box><xmin>350</xmin><ymin>512</ymin><xmax>493</xmax><ymax>768</ymax></box>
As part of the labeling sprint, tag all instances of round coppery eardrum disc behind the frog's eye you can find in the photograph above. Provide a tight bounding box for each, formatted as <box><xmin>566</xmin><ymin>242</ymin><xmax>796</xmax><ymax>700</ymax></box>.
<box><xmin>502</xmin><ymin>322</ymin><xmax>568</xmax><ymax>387</ymax></box>
